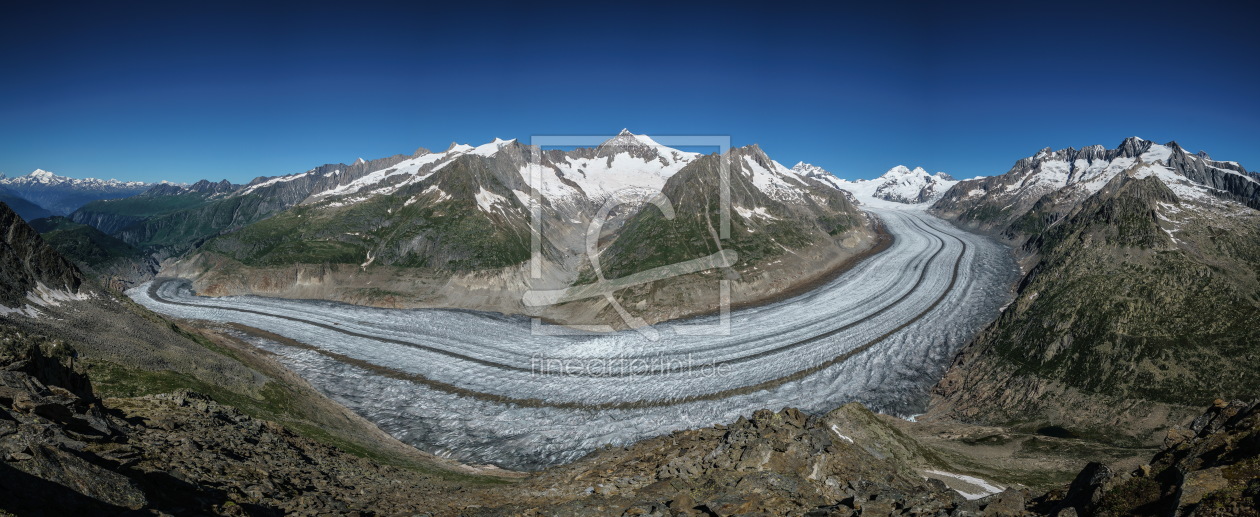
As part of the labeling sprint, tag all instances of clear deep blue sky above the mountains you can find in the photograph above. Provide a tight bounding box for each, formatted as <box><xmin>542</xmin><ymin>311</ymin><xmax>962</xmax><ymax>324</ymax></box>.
<box><xmin>0</xmin><ymin>1</ymin><xmax>1260</xmax><ymax>182</ymax></box>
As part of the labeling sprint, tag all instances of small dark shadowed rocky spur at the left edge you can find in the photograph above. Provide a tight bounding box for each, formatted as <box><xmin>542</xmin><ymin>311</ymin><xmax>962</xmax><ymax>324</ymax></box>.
<box><xmin>0</xmin><ymin>203</ymin><xmax>83</xmax><ymax>308</ymax></box>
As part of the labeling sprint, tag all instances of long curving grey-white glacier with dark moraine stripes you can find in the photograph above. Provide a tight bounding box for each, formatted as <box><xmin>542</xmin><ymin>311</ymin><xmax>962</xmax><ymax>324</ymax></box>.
<box><xmin>127</xmin><ymin>208</ymin><xmax>1016</xmax><ymax>469</ymax></box>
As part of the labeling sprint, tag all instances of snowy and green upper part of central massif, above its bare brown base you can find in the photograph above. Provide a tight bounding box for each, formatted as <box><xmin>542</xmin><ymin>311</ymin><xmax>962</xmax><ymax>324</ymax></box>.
<box><xmin>199</xmin><ymin>130</ymin><xmax>866</xmax><ymax>269</ymax></box>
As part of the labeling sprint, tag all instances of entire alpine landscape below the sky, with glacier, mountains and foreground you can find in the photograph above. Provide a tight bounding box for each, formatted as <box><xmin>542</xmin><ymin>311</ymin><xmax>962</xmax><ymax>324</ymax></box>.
<box><xmin>0</xmin><ymin>130</ymin><xmax>1260</xmax><ymax>516</ymax></box>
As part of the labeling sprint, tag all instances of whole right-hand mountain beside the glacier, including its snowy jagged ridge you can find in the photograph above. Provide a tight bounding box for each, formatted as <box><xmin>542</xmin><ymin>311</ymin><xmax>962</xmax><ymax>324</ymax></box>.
<box><xmin>932</xmin><ymin>139</ymin><xmax>1260</xmax><ymax>443</ymax></box>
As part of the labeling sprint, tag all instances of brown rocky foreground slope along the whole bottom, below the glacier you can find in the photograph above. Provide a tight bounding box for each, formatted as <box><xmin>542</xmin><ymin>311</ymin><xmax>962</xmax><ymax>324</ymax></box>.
<box><xmin>0</xmin><ymin>330</ymin><xmax>1260</xmax><ymax>516</ymax></box>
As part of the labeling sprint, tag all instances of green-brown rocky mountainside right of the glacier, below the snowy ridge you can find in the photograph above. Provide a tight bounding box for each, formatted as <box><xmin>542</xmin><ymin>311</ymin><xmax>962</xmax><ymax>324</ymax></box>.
<box><xmin>939</xmin><ymin>174</ymin><xmax>1260</xmax><ymax>438</ymax></box>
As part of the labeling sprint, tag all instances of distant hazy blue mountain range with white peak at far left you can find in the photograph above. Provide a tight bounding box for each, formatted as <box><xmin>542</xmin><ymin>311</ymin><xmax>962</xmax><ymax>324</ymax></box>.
<box><xmin>0</xmin><ymin>169</ymin><xmax>165</xmax><ymax>216</ymax></box>
